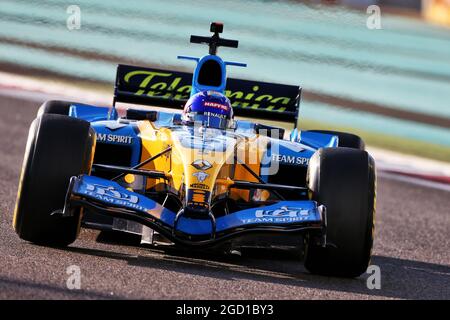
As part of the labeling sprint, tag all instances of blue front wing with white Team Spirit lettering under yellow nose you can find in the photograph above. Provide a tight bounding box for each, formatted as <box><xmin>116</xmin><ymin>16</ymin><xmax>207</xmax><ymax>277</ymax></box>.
<box><xmin>63</xmin><ymin>175</ymin><xmax>326</xmax><ymax>246</ymax></box>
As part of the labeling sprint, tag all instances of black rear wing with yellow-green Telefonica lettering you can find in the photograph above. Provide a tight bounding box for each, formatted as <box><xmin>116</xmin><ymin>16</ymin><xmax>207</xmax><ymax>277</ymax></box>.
<box><xmin>113</xmin><ymin>65</ymin><xmax>301</xmax><ymax>125</ymax></box>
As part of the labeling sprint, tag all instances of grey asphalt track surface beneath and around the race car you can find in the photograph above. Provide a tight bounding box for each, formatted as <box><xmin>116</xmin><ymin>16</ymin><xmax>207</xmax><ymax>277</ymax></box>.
<box><xmin>0</xmin><ymin>97</ymin><xmax>450</xmax><ymax>299</ymax></box>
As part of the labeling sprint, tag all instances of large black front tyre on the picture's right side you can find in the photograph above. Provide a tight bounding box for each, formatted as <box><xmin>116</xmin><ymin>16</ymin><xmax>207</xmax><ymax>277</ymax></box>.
<box><xmin>305</xmin><ymin>148</ymin><xmax>376</xmax><ymax>277</ymax></box>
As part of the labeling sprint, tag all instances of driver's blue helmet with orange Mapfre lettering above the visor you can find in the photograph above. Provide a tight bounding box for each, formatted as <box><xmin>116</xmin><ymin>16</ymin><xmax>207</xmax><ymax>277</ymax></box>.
<box><xmin>182</xmin><ymin>90</ymin><xmax>234</xmax><ymax>129</ymax></box>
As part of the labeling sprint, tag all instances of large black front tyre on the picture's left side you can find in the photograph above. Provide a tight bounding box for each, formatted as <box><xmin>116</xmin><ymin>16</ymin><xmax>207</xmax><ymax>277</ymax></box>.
<box><xmin>13</xmin><ymin>114</ymin><xmax>95</xmax><ymax>246</ymax></box>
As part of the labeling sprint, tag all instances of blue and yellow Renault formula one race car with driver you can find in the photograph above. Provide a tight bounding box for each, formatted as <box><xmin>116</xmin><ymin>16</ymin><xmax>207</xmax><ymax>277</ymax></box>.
<box><xmin>13</xmin><ymin>23</ymin><xmax>376</xmax><ymax>277</ymax></box>
